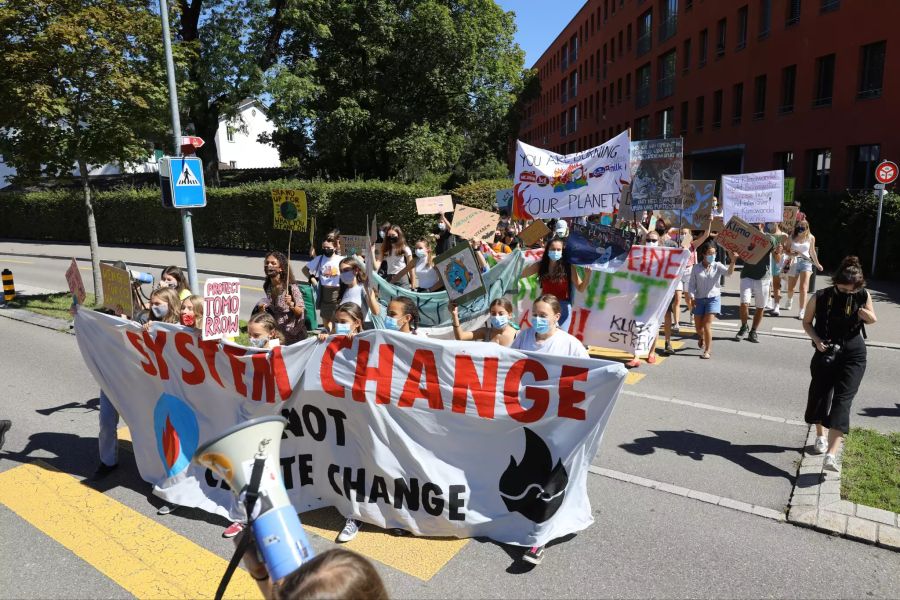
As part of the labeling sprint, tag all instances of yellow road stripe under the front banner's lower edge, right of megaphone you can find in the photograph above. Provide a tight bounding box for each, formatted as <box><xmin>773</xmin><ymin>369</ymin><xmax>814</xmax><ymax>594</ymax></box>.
<box><xmin>300</xmin><ymin>508</ymin><xmax>469</xmax><ymax>581</ymax></box>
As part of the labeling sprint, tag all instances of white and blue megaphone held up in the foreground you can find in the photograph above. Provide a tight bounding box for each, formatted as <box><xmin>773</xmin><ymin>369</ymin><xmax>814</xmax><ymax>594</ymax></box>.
<box><xmin>192</xmin><ymin>416</ymin><xmax>315</xmax><ymax>581</ymax></box>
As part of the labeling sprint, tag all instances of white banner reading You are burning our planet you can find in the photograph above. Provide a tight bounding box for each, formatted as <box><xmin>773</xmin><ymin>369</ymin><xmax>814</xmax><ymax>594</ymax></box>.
<box><xmin>513</xmin><ymin>131</ymin><xmax>631</xmax><ymax>219</ymax></box>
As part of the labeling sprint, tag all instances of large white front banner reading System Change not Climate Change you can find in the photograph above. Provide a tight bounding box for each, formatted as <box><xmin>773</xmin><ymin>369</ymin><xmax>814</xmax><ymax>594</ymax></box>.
<box><xmin>75</xmin><ymin>310</ymin><xmax>626</xmax><ymax>546</ymax></box>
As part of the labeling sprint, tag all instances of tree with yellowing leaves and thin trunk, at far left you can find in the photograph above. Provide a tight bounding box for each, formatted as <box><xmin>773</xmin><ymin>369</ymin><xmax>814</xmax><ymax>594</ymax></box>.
<box><xmin>0</xmin><ymin>0</ymin><xmax>174</xmax><ymax>303</ymax></box>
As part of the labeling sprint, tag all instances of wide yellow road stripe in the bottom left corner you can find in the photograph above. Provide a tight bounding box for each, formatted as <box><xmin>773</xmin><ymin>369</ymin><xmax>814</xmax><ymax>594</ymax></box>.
<box><xmin>0</xmin><ymin>461</ymin><xmax>261</xmax><ymax>598</ymax></box>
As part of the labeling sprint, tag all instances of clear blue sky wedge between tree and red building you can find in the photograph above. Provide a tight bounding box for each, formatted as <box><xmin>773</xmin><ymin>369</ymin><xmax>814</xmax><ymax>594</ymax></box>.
<box><xmin>496</xmin><ymin>0</ymin><xmax>587</xmax><ymax>67</ymax></box>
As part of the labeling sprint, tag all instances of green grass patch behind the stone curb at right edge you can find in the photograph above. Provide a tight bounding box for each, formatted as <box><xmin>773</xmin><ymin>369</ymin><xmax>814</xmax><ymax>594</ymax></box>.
<box><xmin>841</xmin><ymin>427</ymin><xmax>900</xmax><ymax>512</ymax></box>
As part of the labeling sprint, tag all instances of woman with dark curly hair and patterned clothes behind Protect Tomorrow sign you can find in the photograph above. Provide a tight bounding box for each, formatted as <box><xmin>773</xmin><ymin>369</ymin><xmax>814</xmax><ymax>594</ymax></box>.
<box><xmin>257</xmin><ymin>250</ymin><xmax>307</xmax><ymax>344</ymax></box>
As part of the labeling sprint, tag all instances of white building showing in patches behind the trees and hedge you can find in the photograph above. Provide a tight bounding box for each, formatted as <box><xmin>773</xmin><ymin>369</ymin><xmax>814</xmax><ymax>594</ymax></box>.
<box><xmin>0</xmin><ymin>98</ymin><xmax>281</xmax><ymax>188</ymax></box>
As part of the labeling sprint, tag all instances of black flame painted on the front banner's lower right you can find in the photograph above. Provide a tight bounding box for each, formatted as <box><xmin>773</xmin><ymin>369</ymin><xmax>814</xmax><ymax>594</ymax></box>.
<box><xmin>500</xmin><ymin>427</ymin><xmax>569</xmax><ymax>523</ymax></box>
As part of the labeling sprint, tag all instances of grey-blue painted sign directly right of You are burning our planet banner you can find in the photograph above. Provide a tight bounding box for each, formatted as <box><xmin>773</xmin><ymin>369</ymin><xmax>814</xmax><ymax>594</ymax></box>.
<box><xmin>629</xmin><ymin>138</ymin><xmax>684</xmax><ymax>211</ymax></box>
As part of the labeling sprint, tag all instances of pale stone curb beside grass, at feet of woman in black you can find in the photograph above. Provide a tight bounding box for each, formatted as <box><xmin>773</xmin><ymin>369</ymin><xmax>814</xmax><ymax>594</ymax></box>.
<box><xmin>787</xmin><ymin>425</ymin><xmax>900</xmax><ymax>552</ymax></box>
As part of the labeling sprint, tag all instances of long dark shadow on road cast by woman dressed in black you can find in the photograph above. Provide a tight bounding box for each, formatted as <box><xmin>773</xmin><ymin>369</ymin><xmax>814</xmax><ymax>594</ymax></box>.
<box><xmin>619</xmin><ymin>430</ymin><xmax>801</xmax><ymax>483</ymax></box>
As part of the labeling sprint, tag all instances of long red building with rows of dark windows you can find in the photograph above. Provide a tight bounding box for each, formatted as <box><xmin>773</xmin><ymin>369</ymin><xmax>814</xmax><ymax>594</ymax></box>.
<box><xmin>519</xmin><ymin>0</ymin><xmax>900</xmax><ymax>191</ymax></box>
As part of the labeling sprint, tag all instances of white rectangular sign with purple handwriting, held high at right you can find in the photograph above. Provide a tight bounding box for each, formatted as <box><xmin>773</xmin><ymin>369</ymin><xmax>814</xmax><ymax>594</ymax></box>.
<box><xmin>722</xmin><ymin>170</ymin><xmax>784</xmax><ymax>223</ymax></box>
